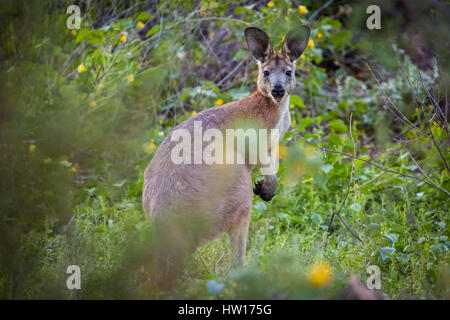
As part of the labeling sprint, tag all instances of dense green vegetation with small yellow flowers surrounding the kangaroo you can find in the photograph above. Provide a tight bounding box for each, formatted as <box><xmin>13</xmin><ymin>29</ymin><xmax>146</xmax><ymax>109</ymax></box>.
<box><xmin>0</xmin><ymin>0</ymin><xmax>450</xmax><ymax>299</ymax></box>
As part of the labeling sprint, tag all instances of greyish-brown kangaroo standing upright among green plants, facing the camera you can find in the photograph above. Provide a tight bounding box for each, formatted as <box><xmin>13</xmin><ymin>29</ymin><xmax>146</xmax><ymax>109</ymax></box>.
<box><xmin>142</xmin><ymin>26</ymin><xmax>310</xmax><ymax>284</ymax></box>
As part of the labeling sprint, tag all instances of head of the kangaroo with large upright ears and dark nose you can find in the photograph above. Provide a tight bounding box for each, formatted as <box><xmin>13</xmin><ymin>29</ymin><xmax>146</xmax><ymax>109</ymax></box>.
<box><xmin>244</xmin><ymin>26</ymin><xmax>310</xmax><ymax>103</ymax></box>
